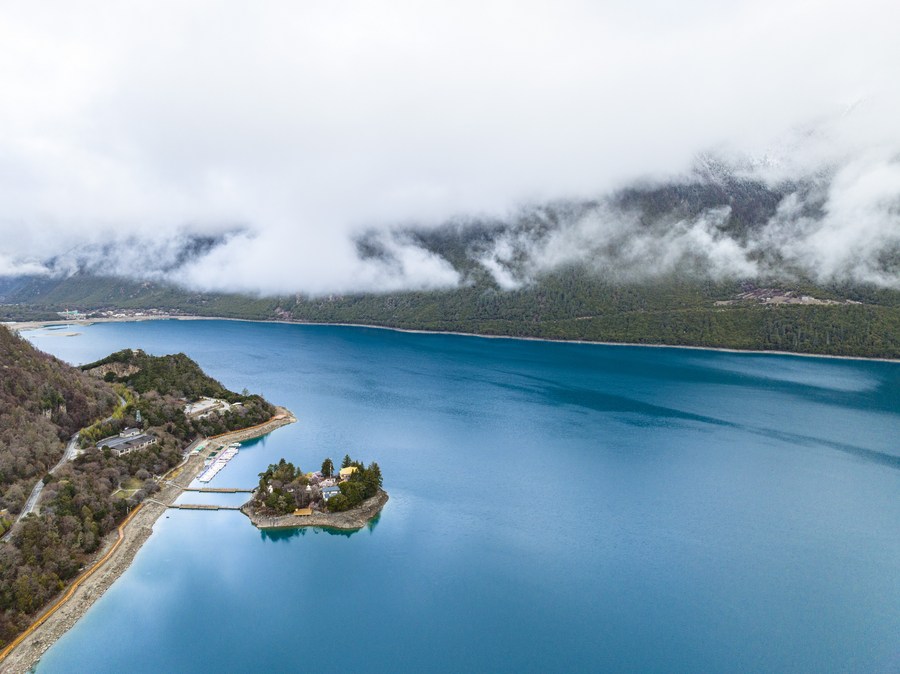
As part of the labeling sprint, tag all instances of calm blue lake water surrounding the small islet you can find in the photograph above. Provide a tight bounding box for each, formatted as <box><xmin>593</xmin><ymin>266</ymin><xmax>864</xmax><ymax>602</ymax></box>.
<box><xmin>25</xmin><ymin>321</ymin><xmax>900</xmax><ymax>673</ymax></box>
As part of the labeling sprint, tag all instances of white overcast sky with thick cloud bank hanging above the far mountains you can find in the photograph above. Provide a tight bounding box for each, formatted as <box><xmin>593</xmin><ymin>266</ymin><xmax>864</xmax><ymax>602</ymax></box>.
<box><xmin>0</xmin><ymin>0</ymin><xmax>900</xmax><ymax>292</ymax></box>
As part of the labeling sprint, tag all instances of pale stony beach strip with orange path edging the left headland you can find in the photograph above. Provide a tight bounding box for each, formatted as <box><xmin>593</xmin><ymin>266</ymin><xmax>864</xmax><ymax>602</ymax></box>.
<box><xmin>0</xmin><ymin>407</ymin><xmax>297</xmax><ymax>674</ymax></box>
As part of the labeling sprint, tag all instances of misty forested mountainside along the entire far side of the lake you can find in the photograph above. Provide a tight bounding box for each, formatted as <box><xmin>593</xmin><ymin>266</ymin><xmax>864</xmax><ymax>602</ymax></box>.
<box><xmin>0</xmin><ymin>172</ymin><xmax>900</xmax><ymax>358</ymax></box>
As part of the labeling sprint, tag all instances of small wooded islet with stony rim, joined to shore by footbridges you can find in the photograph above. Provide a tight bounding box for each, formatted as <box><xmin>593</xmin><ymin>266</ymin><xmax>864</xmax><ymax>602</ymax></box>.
<box><xmin>241</xmin><ymin>454</ymin><xmax>388</xmax><ymax>530</ymax></box>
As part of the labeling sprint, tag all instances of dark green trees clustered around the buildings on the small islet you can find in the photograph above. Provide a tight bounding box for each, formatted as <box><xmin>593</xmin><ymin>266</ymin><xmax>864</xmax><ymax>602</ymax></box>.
<box><xmin>251</xmin><ymin>455</ymin><xmax>382</xmax><ymax>515</ymax></box>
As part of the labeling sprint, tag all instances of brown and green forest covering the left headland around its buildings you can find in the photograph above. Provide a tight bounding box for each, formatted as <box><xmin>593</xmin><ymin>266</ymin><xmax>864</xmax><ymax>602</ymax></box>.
<box><xmin>0</xmin><ymin>328</ymin><xmax>274</xmax><ymax>647</ymax></box>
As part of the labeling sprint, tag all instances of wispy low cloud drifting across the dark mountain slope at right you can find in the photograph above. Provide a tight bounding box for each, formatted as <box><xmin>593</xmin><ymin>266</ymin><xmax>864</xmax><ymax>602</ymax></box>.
<box><xmin>480</xmin><ymin>151</ymin><xmax>900</xmax><ymax>289</ymax></box>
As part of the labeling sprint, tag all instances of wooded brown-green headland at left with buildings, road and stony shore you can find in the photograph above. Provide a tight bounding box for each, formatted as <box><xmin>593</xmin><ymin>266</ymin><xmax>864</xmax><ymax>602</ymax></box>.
<box><xmin>0</xmin><ymin>327</ymin><xmax>296</xmax><ymax>672</ymax></box>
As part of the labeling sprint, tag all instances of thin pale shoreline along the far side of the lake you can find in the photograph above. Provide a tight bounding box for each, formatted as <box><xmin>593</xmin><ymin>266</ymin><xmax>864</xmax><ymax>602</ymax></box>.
<box><xmin>2</xmin><ymin>314</ymin><xmax>900</xmax><ymax>363</ymax></box>
